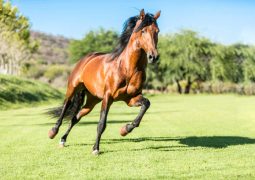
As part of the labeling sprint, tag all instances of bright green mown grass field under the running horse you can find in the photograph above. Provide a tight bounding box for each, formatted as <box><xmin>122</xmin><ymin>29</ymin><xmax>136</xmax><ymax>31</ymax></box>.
<box><xmin>0</xmin><ymin>95</ymin><xmax>255</xmax><ymax>179</ymax></box>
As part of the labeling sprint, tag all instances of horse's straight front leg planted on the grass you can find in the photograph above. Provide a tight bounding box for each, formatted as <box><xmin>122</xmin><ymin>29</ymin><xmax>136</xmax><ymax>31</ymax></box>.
<box><xmin>92</xmin><ymin>94</ymin><xmax>113</xmax><ymax>155</ymax></box>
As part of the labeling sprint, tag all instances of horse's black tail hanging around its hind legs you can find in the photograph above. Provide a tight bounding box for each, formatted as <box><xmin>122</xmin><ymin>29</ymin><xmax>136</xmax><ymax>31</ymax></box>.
<box><xmin>46</xmin><ymin>89</ymin><xmax>86</xmax><ymax>119</ymax></box>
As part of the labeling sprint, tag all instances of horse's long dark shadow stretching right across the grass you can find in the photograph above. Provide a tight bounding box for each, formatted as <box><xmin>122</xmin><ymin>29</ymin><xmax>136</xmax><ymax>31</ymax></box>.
<box><xmin>70</xmin><ymin>136</ymin><xmax>255</xmax><ymax>153</ymax></box>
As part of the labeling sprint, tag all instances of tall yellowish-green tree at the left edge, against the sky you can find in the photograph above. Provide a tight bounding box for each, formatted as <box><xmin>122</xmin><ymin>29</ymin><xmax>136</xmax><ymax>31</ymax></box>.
<box><xmin>0</xmin><ymin>1</ymin><xmax>37</xmax><ymax>74</ymax></box>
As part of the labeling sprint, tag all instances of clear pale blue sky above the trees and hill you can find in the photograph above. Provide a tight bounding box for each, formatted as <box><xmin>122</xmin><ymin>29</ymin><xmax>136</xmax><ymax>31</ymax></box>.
<box><xmin>11</xmin><ymin>0</ymin><xmax>255</xmax><ymax>44</ymax></box>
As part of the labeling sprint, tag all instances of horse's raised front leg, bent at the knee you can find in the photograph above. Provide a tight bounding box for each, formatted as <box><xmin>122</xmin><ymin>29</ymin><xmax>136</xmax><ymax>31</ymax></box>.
<box><xmin>120</xmin><ymin>94</ymin><xmax>150</xmax><ymax>136</ymax></box>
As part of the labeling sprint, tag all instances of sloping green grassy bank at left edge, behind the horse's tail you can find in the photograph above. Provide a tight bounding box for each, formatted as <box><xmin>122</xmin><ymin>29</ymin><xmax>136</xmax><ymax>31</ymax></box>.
<box><xmin>0</xmin><ymin>75</ymin><xmax>62</xmax><ymax>110</ymax></box>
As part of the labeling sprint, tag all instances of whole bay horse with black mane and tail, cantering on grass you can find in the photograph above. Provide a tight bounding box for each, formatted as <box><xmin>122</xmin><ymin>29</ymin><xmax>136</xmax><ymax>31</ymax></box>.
<box><xmin>48</xmin><ymin>9</ymin><xmax>160</xmax><ymax>155</ymax></box>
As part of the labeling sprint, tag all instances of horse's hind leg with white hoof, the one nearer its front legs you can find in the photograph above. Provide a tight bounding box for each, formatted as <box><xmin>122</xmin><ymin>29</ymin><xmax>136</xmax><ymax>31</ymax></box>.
<box><xmin>59</xmin><ymin>93</ymin><xmax>100</xmax><ymax>147</ymax></box>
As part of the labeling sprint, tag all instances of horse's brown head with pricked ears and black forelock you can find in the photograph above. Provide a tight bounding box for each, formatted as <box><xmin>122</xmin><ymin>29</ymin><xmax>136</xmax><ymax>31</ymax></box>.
<box><xmin>133</xmin><ymin>9</ymin><xmax>160</xmax><ymax>63</ymax></box>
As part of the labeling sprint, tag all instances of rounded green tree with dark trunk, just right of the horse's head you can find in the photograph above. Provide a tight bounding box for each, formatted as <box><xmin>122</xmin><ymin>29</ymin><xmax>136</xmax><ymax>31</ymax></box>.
<box><xmin>159</xmin><ymin>30</ymin><xmax>213</xmax><ymax>94</ymax></box>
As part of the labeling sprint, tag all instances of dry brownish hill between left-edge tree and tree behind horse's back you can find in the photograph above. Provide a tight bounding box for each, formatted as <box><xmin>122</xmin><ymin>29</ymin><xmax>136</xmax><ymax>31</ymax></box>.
<box><xmin>30</xmin><ymin>31</ymin><xmax>71</xmax><ymax>64</ymax></box>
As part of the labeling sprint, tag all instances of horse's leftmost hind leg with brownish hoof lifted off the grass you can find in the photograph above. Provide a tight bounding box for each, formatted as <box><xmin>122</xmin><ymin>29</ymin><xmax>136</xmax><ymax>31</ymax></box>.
<box><xmin>48</xmin><ymin>84</ymin><xmax>74</xmax><ymax>139</ymax></box>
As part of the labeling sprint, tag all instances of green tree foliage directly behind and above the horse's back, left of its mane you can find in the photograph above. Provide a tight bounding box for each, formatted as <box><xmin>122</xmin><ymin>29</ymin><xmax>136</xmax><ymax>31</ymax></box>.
<box><xmin>69</xmin><ymin>28</ymin><xmax>118</xmax><ymax>63</ymax></box>
